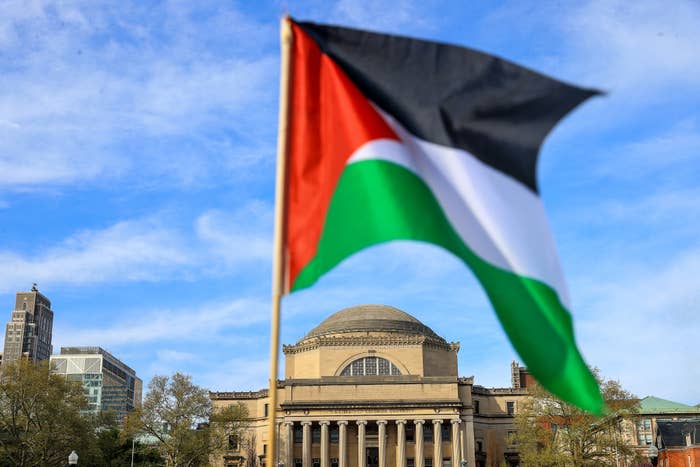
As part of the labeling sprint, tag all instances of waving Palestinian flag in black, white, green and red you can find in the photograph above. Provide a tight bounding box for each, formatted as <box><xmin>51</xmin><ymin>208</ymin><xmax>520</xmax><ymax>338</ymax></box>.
<box><xmin>283</xmin><ymin>21</ymin><xmax>603</xmax><ymax>413</ymax></box>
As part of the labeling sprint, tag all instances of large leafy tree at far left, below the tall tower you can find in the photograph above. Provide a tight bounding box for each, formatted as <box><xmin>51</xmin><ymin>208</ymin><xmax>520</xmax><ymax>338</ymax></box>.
<box><xmin>0</xmin><ymin>360</ymin><xmax>98</xmax><ymax>466</ymax></box>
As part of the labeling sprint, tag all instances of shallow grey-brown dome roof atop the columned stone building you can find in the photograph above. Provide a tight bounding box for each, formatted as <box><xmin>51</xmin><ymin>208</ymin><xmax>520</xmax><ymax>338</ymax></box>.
<box><xmin>302</xmin><ymin>305</ymin><xmax>443</xmax><ymax>341</ymax></box>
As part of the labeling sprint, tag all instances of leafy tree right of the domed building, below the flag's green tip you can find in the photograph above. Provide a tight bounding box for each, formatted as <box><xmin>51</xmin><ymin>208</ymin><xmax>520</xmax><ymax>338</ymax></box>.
<box><xmin>515</xmin><ymin>369</ymin><xmax>638</xmax><ymax>467</ymax></box>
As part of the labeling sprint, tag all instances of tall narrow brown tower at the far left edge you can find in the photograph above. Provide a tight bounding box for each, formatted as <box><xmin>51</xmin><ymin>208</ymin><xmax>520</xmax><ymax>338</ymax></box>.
<box><xmin>2</xmin><ymin>284</ymin><xmax>53</xmax><ymax>363</ymax></box>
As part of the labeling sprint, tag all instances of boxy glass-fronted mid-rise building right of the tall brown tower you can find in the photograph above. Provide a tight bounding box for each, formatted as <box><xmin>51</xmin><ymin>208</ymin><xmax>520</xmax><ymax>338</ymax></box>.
<box><xmin>51</xmin><ymin>347</ymin><xmax>143</xmax><ymax>422</ymax></box>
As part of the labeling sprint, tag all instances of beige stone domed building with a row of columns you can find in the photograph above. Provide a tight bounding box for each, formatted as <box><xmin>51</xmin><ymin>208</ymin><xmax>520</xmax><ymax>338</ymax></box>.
<box><xmin>211</xmin><ymin>305</ymin><xmax>528</xmax><ymax>467</ymax></box>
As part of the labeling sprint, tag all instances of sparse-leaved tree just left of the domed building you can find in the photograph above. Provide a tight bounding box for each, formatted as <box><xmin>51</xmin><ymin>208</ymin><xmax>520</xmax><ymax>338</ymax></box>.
<box><xmin>127</xmin><ymin>373</ymin><xmax>247</xmax><ymax>467</ymax></box>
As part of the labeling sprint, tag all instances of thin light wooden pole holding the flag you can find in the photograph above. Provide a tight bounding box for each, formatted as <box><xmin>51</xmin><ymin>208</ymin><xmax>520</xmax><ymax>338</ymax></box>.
<box><xmin>266</xmin><ymin>15</ymin><xmax>292</xmax><ymax>467</ymax></box>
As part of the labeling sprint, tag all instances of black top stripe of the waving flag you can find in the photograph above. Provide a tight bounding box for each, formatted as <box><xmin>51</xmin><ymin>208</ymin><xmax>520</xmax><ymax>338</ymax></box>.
<box><xmin>297</xmin><ymin>22</ymin><xmax>599</xmax><ymax>193</ymax></box>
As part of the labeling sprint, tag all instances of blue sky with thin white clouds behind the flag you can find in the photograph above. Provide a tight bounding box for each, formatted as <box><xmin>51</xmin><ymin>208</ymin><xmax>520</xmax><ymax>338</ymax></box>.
<box><xmin>0</xmin><ymin>0</ymin><xmax>700</xmax><ymax>405</ymax></box>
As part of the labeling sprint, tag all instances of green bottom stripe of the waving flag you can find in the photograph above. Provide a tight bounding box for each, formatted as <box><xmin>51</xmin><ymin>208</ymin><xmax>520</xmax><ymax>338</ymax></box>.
<box><xmin>293</xmin><ymin>160</ymin><xmax>603</xmax><ymax>414</ymax></box>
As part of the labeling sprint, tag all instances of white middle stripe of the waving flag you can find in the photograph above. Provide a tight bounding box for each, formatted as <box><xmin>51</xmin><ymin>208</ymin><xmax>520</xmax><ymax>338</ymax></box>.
<box><xmin>348</xmin><ymin>112</ymin><xmax>570</xmax><ymax>309</ymax></box>
